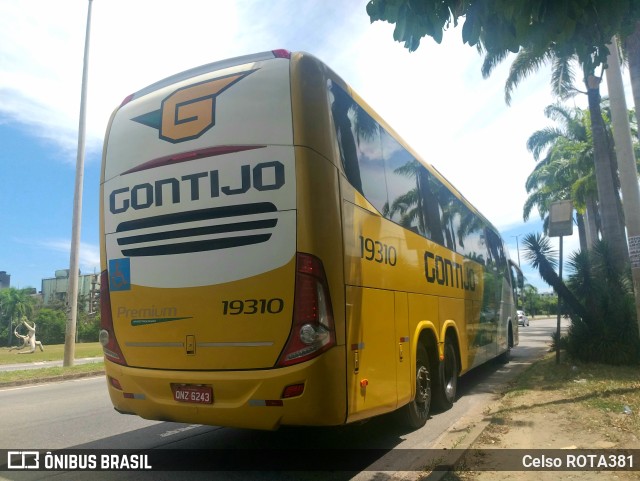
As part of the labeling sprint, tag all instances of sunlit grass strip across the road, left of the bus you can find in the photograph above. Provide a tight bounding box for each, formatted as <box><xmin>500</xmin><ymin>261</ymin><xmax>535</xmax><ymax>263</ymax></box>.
<box><xmin>0</xmin><ymin>342</ymin><xmax>104</xmax><ymax>387</ymax></box>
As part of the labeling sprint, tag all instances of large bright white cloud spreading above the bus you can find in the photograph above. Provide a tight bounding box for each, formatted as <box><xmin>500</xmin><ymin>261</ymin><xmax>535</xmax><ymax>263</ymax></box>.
<box><xmin>0</xmin><ymin>0</ymin><xmax>608</xmax><ymax>232</ymax></box>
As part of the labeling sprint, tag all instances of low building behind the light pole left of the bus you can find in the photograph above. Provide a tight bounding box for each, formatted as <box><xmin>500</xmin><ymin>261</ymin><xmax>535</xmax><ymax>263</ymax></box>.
<box><xmin>42</xmin><ymin>269</ymin><xmax>100</xmax><ymax>314</ymax></box>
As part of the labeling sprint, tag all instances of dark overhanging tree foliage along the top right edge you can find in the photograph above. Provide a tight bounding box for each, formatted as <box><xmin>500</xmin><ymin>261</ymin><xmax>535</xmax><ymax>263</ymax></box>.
<box><xmin>367</xmin><ymin>0</ymin><xmax>640</xmax><ymax>69</ymax></box>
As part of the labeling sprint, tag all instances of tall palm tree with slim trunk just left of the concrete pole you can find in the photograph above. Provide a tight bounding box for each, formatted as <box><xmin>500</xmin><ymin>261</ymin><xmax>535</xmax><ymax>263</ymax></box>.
<box><xmin>482</xmin><ymin>44</ymin><xmax>629</xmax><ymax>267</ymax></box>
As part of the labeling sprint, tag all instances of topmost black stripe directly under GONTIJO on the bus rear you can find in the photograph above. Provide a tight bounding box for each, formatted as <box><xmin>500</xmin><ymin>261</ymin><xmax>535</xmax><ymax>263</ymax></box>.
<box><xmin>116</xmin><ymin>202</ymin><xmax>277</xmax><ymax>232</ymax></box>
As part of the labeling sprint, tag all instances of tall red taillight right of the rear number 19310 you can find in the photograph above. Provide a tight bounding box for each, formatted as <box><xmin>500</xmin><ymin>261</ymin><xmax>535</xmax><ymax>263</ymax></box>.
<box><xmin>278</xmin><ymin>253</ymin><xmax>336</xmax><ymax>366</ymax></box>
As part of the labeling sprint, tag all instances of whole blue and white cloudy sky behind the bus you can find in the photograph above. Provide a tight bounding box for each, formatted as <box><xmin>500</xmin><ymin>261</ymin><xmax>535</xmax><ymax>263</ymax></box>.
<box><xmin>0</xmin><ymin>0</ymin><xmax>620</xmax><ymax>291</ymax></box>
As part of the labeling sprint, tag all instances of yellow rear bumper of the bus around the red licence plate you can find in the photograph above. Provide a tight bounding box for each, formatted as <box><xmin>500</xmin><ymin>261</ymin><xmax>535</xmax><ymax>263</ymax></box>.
<box><xmin>105</xmin><ymin>346</ymin><xmax>347</xmax><ymax>430</ymax></box>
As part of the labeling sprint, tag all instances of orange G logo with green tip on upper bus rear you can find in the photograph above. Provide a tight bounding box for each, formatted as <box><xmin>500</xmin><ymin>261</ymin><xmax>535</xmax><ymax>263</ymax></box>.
<box><xmin>132</xmin><ymin>70</ymin><xmax>255</xmax><ymax>143</ymax></box>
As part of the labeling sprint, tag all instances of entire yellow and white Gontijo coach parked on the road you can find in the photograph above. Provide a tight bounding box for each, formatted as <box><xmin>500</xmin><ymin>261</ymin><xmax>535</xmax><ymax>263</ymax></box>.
<box><xmin>100</xmin><ymin>50</ymin><xmax>518</xmax><ymax>429</ymax></box>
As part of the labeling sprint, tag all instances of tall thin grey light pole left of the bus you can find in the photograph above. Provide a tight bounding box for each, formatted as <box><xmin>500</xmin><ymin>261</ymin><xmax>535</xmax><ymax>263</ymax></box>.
<box><xmin>62</xmin><ymin>0</ymin><xmax>93</xmax><ymax>367</ymax></box>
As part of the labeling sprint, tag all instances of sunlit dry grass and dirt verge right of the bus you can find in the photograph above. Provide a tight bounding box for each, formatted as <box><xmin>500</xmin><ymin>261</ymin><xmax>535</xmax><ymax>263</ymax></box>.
<box><xmin>442</xmin><ymin>353</ymin><xmax>640</xmax><ymax>481</ymax></box>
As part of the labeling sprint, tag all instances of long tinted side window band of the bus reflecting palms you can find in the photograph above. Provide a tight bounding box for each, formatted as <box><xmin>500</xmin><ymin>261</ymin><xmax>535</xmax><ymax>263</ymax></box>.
<box><xmin>329</xmin><ymin>79</ymin><xmax>506</xmax><ymax>270</ymax></box>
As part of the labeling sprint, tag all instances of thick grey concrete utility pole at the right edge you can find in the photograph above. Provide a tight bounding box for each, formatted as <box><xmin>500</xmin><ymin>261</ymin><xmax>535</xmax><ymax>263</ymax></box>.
<box><xmin>606</xmin><ymin>37</ymin><xmax>640</xmax><ymax>330</ymax></box>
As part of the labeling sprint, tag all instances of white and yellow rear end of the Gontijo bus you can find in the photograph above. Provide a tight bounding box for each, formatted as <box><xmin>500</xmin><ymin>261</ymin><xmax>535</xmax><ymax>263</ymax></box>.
<box><xmin>100</xmin><ymin>51</ymin><xmax>346</xmax><ymax>429</ymax></box>
